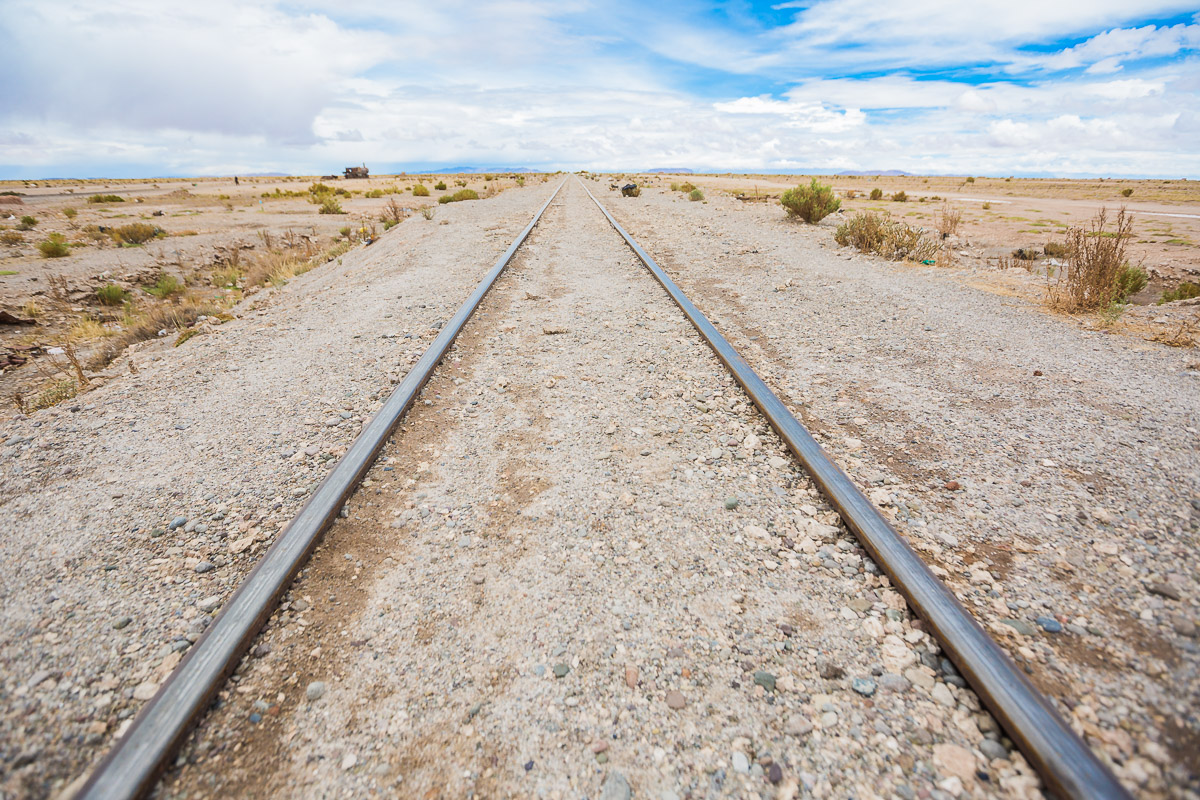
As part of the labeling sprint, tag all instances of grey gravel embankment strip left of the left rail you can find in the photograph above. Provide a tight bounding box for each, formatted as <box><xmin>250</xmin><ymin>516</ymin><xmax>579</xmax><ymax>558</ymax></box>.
<box><xmin>0</xmin><ymin>185</ymin><xmax>552</xmax><ymax>798</ymax></box>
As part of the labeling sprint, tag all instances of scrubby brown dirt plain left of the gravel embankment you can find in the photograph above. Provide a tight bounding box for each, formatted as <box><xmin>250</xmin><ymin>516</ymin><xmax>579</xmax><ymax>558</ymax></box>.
<box><xmin>0</xmin><ymin>175</ymin><xmax>541</xmax><ymax>420</ymax></box>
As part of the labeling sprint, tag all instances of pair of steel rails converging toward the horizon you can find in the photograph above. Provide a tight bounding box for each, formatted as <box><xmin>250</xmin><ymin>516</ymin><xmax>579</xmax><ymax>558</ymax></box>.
<box><xmin>77</xmin><ymin>179</ymin><xmax>1129</xmax><ymax>799</ymax></box>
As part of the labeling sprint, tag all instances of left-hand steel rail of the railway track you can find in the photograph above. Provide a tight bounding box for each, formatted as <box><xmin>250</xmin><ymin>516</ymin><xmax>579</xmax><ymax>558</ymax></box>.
<box><xmin>76</xmin><ymin>180</ymin><xmax>566</xmax><ymax>800</ymax></box>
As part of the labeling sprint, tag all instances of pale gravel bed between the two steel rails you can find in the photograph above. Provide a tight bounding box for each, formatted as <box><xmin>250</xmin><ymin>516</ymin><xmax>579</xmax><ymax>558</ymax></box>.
<box><xmin>162</xmin><ymin>181</ymin><xmax>1039</xmax><ymax>799</ymax></box>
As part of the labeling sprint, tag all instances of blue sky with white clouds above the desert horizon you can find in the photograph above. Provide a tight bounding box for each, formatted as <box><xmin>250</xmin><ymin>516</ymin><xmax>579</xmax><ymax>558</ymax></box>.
<box><xmin>0</xmin><ymin>0</ymin><xmax>1200</xmax><ymax>179</ymax></box>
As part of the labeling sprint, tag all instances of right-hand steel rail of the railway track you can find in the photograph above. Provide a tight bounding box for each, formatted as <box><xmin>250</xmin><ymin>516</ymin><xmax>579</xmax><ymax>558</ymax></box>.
<box><xmin>580</xmin><ymin>181</ymin><xmax>1132</xmax><ymax>800</ymax></box>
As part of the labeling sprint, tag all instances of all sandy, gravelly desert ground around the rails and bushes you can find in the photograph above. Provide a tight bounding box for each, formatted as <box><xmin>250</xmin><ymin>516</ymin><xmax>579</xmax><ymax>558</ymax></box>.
<box><xmin>0</xmin><ymin>175</ymin><xmax>1200</xmax><ymax>800</ymax></box>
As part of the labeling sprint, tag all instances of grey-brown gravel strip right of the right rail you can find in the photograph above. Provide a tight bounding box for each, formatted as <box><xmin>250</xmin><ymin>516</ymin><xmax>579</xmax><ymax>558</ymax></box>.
<box><xmin>601</xmin><ymin>184</ymin><xmax>1200</xmax><ymax>798</ymax></box>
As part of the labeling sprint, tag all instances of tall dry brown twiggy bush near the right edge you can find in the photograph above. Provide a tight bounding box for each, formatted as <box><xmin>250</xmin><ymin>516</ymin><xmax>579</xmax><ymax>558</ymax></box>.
<box><xmin>1046</xmin><ymin>207</ymin><xmax>1133</xmax><ymax>314</ymax></box>
